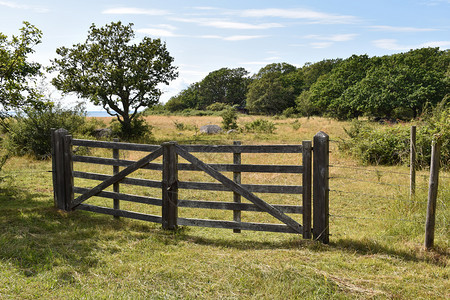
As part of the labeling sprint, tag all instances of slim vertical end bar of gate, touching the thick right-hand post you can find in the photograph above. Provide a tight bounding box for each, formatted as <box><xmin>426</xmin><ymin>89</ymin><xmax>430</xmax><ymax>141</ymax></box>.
<box><xmin>302</xmin><ymin>141</ymin><xmax>312</xmax><ymax>239</ymax></box>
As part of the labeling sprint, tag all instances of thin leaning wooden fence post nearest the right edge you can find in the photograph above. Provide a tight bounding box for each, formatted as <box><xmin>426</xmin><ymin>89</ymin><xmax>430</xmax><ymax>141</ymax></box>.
<box><xmin>425</xmin><ymin>137</ymin><xmax>441</xmax><ymax>249</ymax></box>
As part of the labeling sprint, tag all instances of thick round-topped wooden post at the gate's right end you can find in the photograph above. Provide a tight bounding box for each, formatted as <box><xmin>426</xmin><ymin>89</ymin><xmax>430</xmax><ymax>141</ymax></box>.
<box><xmin>313</xmin><ymin>131</ymin><xmax>330</xmax><ymax>244</ymax></box>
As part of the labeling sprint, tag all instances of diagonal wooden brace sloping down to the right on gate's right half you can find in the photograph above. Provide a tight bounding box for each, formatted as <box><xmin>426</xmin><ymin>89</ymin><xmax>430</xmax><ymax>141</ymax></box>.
<box><xmin>175</xmin><ymin>145</ymin><xmax>302</xmax><ymax>233</ymax></box>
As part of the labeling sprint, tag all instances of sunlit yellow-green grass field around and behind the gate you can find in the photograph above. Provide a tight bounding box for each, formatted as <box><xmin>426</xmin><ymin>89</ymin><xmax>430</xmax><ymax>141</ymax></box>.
<box><xmin>0</xmin><ymin>116</ymin><xmax>450</xmax><ymax>299</ymax></box>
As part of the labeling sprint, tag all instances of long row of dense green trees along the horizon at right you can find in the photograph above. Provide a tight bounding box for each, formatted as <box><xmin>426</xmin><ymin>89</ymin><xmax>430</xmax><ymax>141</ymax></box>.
<box><xmin>165</xmin><ymin>48</ymin><xmax>450</xmax><ymax>119</ymax></box>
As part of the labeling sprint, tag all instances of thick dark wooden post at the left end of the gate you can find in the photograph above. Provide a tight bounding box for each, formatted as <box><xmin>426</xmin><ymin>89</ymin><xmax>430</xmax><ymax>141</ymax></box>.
<box><xmin>52</xmin><ymin>128</ymin><xmax>73</xmax><ymax>211</ymax></box>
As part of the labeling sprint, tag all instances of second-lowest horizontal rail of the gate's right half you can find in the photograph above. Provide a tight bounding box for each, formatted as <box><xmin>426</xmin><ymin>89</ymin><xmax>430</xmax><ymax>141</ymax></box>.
<box><xmin>178</xmin><ymin>200</ymin><xmax>302</xmax><ymax>214</ymax></box>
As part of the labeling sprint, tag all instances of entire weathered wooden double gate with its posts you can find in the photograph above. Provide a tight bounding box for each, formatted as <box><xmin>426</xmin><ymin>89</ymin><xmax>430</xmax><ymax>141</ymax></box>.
<box><xmin>52</xmin><ymin>129</ymin><xmax>329</xmax><ymax>243</ymax></box>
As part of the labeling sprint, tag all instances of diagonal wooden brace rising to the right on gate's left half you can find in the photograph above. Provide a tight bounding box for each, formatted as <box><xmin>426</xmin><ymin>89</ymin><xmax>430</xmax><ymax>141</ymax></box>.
<box><xmin>72</xmin><ymin>147</ymin><xmax>162</xmax><ymax>208</ymax></box>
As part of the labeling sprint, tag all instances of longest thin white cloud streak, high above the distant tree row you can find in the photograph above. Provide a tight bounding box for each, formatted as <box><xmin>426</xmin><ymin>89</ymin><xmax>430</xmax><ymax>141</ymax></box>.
<box><xmin>240</xmin><ymin>8</ymin><xmax>359</xmax><ymax>24</ymax></box>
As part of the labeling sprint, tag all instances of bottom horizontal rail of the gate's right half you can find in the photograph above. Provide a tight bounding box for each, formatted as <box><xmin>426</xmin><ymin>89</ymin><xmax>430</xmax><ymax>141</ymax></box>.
<box><xmin>178</xmin><ymin>218</ymin><xmax>301</xmax><ymax>233</ymax></box>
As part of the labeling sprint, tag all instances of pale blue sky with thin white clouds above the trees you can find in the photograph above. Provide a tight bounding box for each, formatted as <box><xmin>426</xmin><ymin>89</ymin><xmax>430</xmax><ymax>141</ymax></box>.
<box><xmin>0</xmin><ymin>0</ymin><xmax>450</xmax><ymax>110</ymax></box>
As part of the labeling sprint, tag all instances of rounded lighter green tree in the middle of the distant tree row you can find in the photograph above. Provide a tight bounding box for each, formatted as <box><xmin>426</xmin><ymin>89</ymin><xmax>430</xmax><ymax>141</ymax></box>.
<box><xmin>247</xmin><ymin>63</ymin><xmax>301</xmax><ymax>115</ymax></box>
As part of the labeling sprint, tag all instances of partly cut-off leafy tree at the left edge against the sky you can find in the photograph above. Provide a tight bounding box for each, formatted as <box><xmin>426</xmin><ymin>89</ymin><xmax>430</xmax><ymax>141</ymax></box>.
<box><xmin>0</xmin><ymin>22</ymin><xmax>42</xmax><ymax>119</ymax></box>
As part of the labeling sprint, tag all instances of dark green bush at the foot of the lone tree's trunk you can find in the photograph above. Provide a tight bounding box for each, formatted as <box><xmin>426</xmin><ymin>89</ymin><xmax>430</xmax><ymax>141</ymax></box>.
<box><xmin>110</xmin><ymin>115</ymin><xmax>153</xmax><ymax>143</ymax></box>
